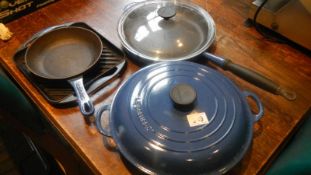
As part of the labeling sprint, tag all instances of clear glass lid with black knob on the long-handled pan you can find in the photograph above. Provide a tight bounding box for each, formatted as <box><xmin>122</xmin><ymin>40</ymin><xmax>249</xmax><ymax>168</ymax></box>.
<box><xmin>118</xmin><ymin>0</ymin><xmax>215</xmax><ymax>61</ymax></box>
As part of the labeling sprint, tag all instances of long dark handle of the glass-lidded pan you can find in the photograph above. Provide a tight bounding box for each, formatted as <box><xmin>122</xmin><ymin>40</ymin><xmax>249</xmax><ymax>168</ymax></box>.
<box><xmin>203</xmin><ymin>52</ymin><xmax>296</xmax><ymax>100</ymax></box>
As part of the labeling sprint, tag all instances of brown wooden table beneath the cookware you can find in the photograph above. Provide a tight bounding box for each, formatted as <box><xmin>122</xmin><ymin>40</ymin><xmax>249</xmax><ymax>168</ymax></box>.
<box><xmin>0</xmin><ymin>0</ymin><xmax>311</xmax><ymax>175</ymax></box>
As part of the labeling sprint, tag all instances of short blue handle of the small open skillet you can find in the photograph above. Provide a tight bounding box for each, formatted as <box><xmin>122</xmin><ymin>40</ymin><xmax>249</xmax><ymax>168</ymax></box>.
<box><xmin>69</xmin><ymin>76</ymin><xmax>95</xmax><ymax>116</ymax></box>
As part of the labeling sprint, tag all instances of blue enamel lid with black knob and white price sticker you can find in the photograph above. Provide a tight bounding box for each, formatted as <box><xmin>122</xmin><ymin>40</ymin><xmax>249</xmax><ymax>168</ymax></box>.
<box><xmin>110</xmin><ymin>61</ymin><xmax>253</xmax><ymax>174</ymax></box>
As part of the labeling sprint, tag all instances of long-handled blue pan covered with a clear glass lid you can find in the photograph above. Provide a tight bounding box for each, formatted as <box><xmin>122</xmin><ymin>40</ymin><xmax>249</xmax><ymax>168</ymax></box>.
<box><xmin>118</xmin><ymin>0</ymin><xmax>296</xmax><ymax>100</ymax></box>
